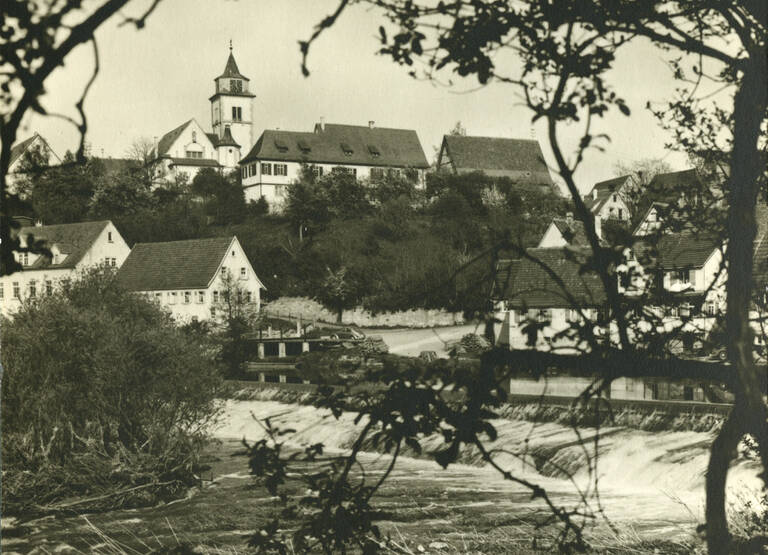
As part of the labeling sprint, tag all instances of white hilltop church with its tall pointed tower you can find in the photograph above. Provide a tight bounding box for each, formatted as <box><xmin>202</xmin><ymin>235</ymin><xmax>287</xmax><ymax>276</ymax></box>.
<box><xmin>152</xmin><ymin>44</ymin><xmax>256</xmax><ymax>182</ymax></box>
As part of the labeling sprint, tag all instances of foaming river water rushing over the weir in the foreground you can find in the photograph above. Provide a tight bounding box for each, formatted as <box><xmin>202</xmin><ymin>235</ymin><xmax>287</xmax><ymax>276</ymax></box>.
<box><xmin>2</xmin><ymin>401</ymin><xmax>760</xmax><ymax>553</ymax></box>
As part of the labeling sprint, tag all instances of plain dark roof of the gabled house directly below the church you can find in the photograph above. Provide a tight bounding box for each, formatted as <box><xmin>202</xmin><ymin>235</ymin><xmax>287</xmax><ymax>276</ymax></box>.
<box><xmin>117</xmin><ymin>236</ymin><xmax>234</xmax><ymax>291</ymax></box>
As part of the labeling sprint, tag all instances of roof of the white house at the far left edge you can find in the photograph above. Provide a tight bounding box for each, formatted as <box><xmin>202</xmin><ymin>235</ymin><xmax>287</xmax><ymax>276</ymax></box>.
<box><xmin>19</xmin><ymin>220</ymin><xmax>110</xmax><ymax>270</ymax></box>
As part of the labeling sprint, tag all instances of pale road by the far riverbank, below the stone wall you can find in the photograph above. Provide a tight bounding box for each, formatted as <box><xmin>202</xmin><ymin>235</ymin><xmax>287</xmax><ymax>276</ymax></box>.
<box><xmin>365</xmin><ymin>324</ymin><xmax>483</xmax><ymax>357</ymax></box>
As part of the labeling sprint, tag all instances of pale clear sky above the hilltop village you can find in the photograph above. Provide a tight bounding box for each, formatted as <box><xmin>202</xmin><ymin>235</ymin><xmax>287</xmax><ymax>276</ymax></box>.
<box><xmin>24</xmin><ymin>0</ymin><xmax>687</xmax><ymax>192</ymax></box>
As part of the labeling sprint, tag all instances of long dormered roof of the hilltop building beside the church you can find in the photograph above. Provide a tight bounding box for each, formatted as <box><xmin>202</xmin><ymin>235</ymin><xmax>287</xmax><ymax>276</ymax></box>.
<box><xmin>240</xmin><ymin>124</ymin><xmax>429</xmax><ymax>168</ymax></box>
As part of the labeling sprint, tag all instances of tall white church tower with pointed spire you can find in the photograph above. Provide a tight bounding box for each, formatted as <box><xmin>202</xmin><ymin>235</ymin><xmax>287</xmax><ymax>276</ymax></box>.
<box><xmin>209</xmin><ymin>41</ymin><xmax>256</xmax><ymax>159</ymax></box>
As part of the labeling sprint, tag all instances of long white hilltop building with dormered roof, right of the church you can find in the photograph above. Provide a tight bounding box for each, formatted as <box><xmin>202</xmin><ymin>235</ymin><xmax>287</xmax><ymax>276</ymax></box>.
<box><xmin>240</xmin><ymin>120</ymin><xmax>429</xmax><ymax>210</ymax></box>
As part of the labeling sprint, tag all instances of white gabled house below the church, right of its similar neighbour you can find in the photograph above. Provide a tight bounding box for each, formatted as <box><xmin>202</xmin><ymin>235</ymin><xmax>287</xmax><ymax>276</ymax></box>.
<box><xmin>117</xmin><ymin>236</ymin><xmax>264</xmax><ymax>323</ymax></box>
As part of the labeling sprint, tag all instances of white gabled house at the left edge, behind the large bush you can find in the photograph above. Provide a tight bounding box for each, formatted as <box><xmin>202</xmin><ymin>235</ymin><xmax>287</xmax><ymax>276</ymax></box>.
<box><xmin>0</xmin><ymin>221</ymin><xmax>131</xmax><ymax>316</ymax></box>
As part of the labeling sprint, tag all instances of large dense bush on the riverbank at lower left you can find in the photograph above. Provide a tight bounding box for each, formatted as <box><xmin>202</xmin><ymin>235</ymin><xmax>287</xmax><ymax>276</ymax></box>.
<box><xmin>2</xmin><ymin>269</ymin><xmax>223</xmax><ymax>511</ymax></box>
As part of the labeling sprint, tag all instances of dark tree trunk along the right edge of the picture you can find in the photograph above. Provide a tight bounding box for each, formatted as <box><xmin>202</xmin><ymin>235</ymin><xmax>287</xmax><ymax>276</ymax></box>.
<box><xmin>706</xmin><ymin>49</ymin><xmax>768</xmax><ymax>555</ymax></box>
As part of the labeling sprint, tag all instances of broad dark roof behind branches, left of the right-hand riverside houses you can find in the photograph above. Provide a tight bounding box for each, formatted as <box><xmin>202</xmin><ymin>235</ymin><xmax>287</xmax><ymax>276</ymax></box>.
<box><xmin>494</xmin><ymin>249</ymin><xmax>606</xmax><ymax>309</ymax></box>
